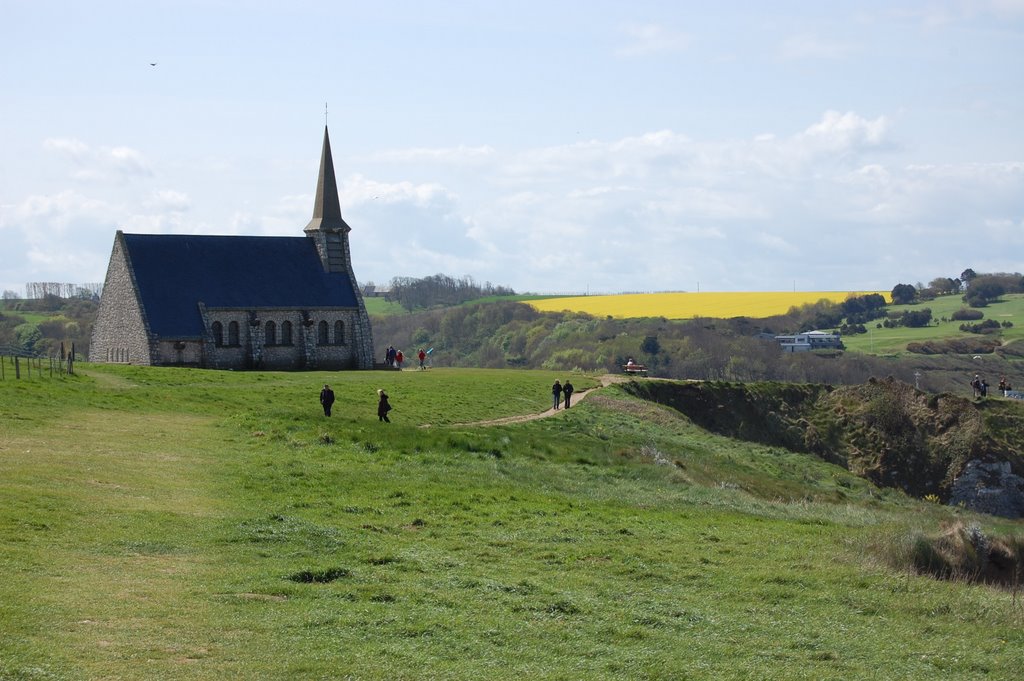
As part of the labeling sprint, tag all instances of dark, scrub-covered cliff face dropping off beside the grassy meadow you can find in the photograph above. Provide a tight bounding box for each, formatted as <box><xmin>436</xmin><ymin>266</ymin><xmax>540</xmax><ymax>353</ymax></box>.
<box><xmin>626</xmin><ymin>379</ymin><xmax>1024</xmax><ymax>517</ymax></box>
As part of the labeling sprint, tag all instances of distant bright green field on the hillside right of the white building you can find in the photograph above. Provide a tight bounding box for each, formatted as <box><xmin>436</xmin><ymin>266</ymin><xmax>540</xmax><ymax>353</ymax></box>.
<box><xmin>843</xmin><ymin>294</ymin><xmax>1024</xmax><ymax>355</ymax></box>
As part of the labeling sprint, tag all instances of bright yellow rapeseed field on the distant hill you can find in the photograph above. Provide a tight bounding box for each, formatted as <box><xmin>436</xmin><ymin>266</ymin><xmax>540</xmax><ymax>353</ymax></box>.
<box><xmin>528</xmin><ymin>291</ymin><xmax>890</xmax><ymax>320</ymax></box>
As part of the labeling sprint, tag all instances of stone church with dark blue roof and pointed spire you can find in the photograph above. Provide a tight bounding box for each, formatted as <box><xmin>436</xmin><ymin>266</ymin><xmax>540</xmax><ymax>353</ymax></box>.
<box><xmin>89</xmin><ymin>126</ymin><xmax>374</xmax><ymax>370</ymax></box>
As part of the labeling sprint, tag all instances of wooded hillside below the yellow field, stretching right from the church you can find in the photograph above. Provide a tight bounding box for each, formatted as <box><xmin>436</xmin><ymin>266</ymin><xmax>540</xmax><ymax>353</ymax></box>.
<box><xmin>373</xmin><ymin>295</ymin><xmax>1024</xmax><ymax>394</ymax></box>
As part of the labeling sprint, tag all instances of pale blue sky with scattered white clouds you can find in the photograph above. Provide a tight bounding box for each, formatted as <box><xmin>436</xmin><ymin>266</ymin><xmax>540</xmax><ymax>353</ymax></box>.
<box><xmin>0</xmin><ymin>0</ymin><xmax>1024</xmax><ymax>294</ymax></box>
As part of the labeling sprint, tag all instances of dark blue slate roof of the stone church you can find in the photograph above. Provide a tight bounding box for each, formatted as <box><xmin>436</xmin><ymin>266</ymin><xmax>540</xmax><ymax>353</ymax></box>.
<box><xmin>123</xmin><ymin>235</ymin><xmax>358</xmax><ymax>338</ymax></box>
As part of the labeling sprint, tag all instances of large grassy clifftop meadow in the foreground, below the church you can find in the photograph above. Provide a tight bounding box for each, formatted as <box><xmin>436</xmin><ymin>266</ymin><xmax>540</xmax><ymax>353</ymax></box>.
<box><xmin>0</xmin><ymin>365</ymin><xmax>1024</xmax><ymax>680</ymax></box>
